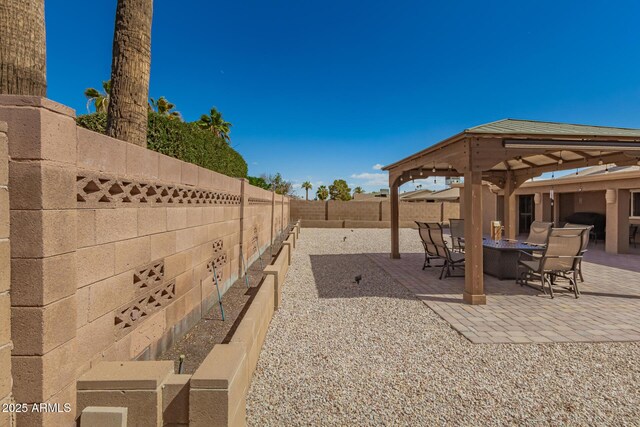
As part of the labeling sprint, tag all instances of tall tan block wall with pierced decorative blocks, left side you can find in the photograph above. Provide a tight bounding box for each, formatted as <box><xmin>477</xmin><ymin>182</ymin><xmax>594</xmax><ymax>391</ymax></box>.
<box><xmin>0</xmin><ymin>96</ymin><xmax>288</xmax><ymax>426</ymax></box>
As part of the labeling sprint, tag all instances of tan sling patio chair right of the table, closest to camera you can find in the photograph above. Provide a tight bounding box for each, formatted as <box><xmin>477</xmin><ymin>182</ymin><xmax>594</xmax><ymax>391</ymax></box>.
<box><xmin>516</xmin><ymin>228</ymin><xmax>587</xmax><ymax>298</ymax></box>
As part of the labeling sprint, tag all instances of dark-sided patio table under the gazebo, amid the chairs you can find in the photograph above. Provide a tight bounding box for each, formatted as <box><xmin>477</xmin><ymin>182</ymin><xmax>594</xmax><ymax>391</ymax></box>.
<box><xmin>482</xmin><ymin>236</ymin><xmax>544</xmax><ymax>280</ymax></box>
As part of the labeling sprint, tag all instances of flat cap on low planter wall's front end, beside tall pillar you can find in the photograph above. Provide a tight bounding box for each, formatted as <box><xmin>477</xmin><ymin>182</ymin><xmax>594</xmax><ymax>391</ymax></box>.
<box><xmin>76</xmin><ymin>360</ymin><xmax>174</xmax><ymax>390</ymax></box>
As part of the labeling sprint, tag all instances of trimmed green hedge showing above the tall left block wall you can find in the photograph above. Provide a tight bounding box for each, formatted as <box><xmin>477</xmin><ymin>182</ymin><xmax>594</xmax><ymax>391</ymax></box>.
<box><xmin>76</xmin><ymin>112</ymin><xmax>247</xmax><ymax>178</ymax></box>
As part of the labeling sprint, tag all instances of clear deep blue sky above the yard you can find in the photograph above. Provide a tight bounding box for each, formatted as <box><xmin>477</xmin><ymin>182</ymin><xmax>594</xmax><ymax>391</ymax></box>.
<box><xmin>46</xmin><ymin>0</ymin><xmax>640</xmax><ymax>194</ymax></box>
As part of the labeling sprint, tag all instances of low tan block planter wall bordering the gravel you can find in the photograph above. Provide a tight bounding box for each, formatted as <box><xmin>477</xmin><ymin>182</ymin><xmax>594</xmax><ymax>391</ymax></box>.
<box><xmin>77</xmin><ymin>224</ymin><xmax>300</xmax><ymax>427</ymax></box>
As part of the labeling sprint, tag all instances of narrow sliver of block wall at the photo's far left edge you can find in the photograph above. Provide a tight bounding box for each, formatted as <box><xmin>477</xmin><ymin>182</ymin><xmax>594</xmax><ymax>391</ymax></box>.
<box><xmin>0</xmin><ymin>122</ymin><xmax>14</xmax><ymax>426</ymax></box>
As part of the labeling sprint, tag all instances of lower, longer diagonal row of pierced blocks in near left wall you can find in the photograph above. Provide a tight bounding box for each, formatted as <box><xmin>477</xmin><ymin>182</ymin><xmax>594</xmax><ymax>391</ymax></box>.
<box><xmin>114</xmin><ymin>281</ymin><xmax>176</xmax><ymax>339</ymax></box>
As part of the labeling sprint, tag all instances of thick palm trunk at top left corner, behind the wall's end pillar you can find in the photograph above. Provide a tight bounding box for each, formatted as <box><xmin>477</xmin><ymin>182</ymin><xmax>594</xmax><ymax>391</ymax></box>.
<box><xmin>0</xmin><ymin>0</ymin><xmax>47</xmax><ymax>96</ymax></box>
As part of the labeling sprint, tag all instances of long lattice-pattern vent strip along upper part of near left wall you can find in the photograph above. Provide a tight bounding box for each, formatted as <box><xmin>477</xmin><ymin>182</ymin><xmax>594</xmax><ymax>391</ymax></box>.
<box><xmin>76</xmin><ymin>175</ymin><xmax>241</xmax><ymax>206</ymax></box>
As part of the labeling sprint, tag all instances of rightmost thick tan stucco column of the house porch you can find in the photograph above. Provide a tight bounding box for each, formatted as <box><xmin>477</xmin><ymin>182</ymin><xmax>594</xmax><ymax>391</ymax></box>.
<box><xmin>605</xmin><ymin>189</ymin><xmax>629</xmax><ymax>254</ymax></box>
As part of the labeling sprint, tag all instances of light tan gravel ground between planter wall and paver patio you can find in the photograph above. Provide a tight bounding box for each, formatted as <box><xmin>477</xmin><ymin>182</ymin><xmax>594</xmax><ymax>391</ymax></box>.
<box><xmin>247</xmin><ymin>229</ymin><xmax>640</xmax><ymax>426</ymax></box>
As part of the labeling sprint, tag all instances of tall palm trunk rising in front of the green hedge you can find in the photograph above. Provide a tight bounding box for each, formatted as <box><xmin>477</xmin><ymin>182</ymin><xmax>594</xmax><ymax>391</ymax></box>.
<box><xmin>107</xmin><ymin>0</ymin><xmax>153</xmax><ymax>147</ymax></box>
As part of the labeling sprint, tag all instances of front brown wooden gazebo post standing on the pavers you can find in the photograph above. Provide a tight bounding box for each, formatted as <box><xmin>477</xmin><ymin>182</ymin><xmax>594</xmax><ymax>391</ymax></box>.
<box><xmin>462</xmin><ymin>171</ymin><xmax>487</xmax><ymax>304</ymax></box>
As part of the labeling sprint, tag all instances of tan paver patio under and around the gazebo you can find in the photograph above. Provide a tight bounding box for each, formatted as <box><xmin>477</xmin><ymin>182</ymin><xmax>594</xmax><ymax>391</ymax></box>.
<box><xmin>369</xmin><ymin>245</ymin><xmax>640</xmax><ymax>343</ymax></box>
